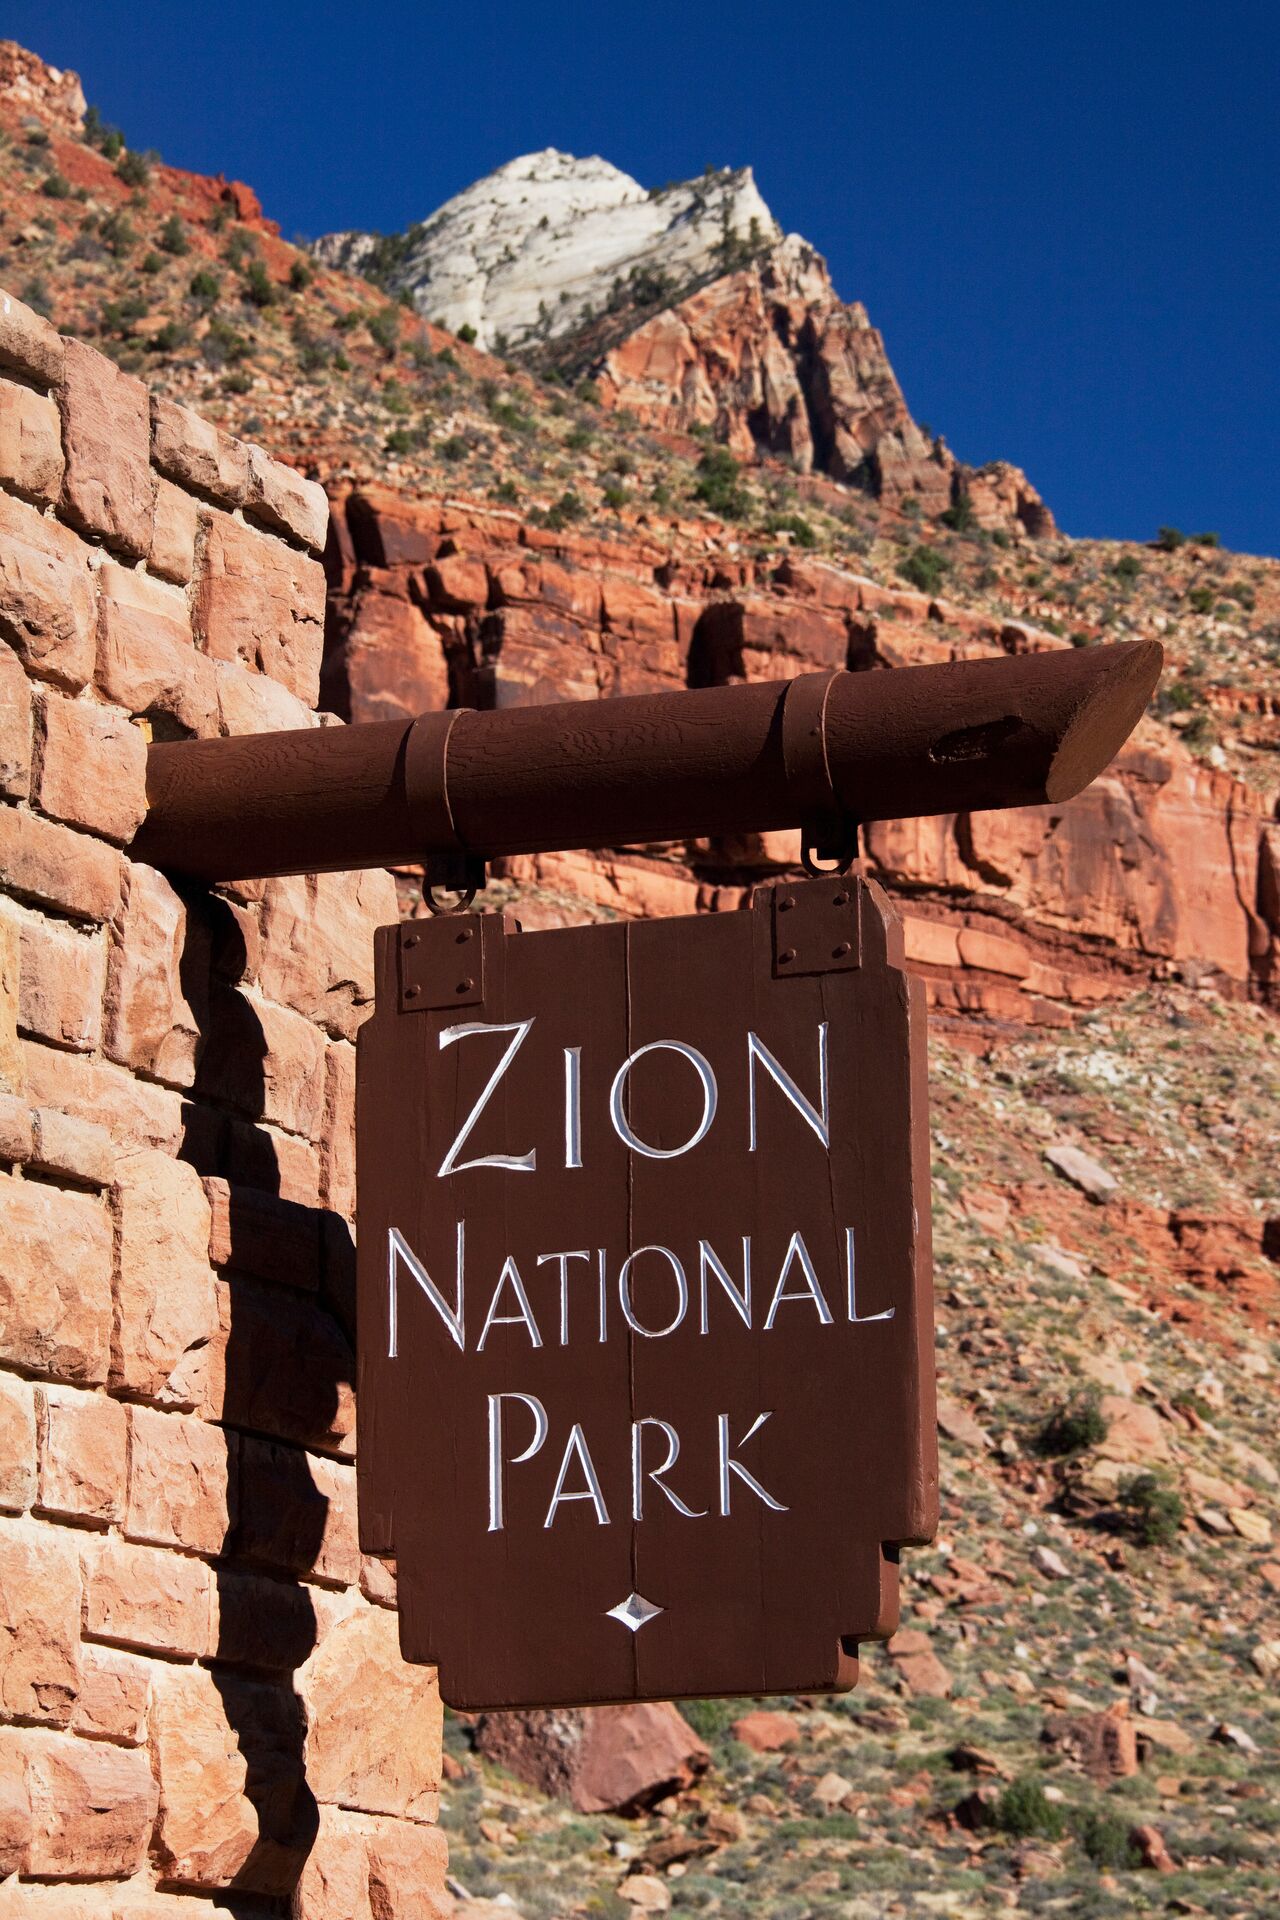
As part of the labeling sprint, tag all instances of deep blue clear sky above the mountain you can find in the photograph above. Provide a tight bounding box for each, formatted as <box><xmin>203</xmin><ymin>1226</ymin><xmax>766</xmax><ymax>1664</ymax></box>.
<box><xmin>12</xmin><ymin>0</ymin><xmax>1280</xmax><ymax>553</ymax></box>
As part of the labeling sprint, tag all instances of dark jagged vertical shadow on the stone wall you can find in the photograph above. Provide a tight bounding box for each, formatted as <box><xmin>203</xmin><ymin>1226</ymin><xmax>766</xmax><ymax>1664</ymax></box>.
<box><xmin>171</xmin><ymin>887</ymin><xmax>355</xmax><ymax>1920</ymax></box>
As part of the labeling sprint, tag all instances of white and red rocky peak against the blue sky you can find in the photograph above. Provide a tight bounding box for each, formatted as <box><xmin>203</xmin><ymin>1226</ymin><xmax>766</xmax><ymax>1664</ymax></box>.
<box><xmin>315</xmin><ymin>148</ymin><xmax>1054</xmax><ymax>534</ymax></box>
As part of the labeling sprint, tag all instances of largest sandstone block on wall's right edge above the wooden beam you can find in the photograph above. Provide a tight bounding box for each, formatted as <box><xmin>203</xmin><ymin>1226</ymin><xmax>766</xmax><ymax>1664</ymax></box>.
<box><xmin>192</xmin><ymin>513</ymin><xmax>324</xmax><ymax>707</ymax></box>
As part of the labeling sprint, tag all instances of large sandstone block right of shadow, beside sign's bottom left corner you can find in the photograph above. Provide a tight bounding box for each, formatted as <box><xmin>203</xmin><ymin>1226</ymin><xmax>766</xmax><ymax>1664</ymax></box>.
<box><xmin>297</xmin><ymin>1607</ymin><xmax>443</xmax><ymax>1820</ymax></box>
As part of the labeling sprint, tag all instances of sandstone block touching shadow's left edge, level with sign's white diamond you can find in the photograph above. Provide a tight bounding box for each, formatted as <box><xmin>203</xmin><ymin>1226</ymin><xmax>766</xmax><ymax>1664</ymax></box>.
<box><xmin>83</xmin><ymin>1538</ymin><xmax>213</xmax><ymax>1661</ymax></box>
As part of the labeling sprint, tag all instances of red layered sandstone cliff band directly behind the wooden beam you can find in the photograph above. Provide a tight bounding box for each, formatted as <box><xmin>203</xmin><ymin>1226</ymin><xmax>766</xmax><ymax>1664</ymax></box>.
<box><xmin>324</xmin><ymin>488</ymin><xmax>1280</xmax><ymax>1025</ymax></box>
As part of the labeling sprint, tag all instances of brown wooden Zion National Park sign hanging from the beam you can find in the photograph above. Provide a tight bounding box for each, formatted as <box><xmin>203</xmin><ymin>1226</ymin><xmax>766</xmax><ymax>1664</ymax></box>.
<box><xmin>357</xmin><ymin>877</ymin><xmax>936</xmax><ymax>1709</ymax></box>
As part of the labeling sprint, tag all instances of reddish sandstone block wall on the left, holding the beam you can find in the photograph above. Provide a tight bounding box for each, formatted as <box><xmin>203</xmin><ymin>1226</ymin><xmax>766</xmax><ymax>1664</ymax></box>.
<box><xmin>0</xmin><ymin>294</ymin><xmax>443</xmax><ymax>1920</ymax></box>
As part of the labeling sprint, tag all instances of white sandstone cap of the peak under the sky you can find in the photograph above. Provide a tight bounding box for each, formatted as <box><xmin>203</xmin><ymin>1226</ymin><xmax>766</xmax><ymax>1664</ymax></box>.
<box><xmin>315</xmin><ymin>148</ymin><xmax>781</xmax><ymax>351</ymax></box>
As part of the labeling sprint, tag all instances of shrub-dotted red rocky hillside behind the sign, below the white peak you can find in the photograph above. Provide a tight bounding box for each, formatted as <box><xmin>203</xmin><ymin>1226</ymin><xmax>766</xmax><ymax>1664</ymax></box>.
<box><xmin>0</xmin><ymin>37</ymin><xmax>1280</xmax><ymax>1920</ymax></box>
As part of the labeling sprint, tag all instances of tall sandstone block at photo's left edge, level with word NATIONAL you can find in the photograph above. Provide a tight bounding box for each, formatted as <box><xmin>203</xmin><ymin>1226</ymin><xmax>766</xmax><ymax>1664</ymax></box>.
<box><xmin>0</xmin><ymin>1177</ymin><xmax>111</xmax><ymax>1384</ymax></box>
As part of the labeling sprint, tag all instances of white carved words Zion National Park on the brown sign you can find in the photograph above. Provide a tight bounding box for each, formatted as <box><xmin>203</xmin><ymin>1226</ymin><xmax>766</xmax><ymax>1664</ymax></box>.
<box><xmin>388</xmin><ymin>1020</ymin><xmax>894</xmax><ymax>1532</ymax></box>
